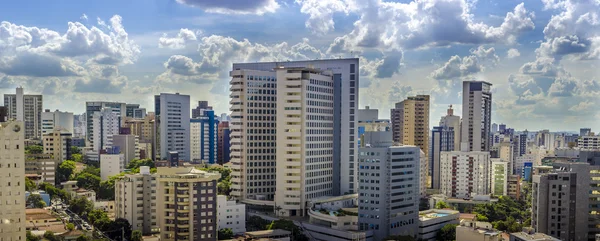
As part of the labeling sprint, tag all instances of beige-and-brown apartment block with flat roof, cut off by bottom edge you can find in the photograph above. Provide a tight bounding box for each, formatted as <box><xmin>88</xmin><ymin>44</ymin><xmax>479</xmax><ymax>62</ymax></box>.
<box><xmin>156</xmin><ymin>168</ymin><xmax>221</xmax><ymax>241</ymax></box>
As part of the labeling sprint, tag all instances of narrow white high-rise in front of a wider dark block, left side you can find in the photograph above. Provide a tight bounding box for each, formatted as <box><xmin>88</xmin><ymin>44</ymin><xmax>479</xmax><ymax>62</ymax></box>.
<box><xmin>91</xmin><ymin>108</ymin><xmax>122</xmax><ymax>152</ymax></box>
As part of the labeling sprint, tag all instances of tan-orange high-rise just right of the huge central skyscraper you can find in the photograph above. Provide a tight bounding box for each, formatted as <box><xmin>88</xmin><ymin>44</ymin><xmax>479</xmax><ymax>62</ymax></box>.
<box><xmin>390</xmin><ymin>95</ymin><xmax>429</xmax><ymax>155</ymax></box>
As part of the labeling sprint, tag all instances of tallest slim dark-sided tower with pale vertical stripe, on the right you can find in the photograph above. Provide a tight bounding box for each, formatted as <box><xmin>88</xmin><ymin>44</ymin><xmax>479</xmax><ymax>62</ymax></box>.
<box><xmin>461</xmin><ymin>81</ymin><xmax>492</xmax><ymax>151</ymax></box>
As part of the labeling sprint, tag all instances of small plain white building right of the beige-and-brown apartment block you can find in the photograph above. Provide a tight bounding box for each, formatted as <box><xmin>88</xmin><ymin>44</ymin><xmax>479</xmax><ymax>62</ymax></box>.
<box><xmin>217</xmin><ymin>195</ymin><xmax>246</xmax><ymax>234</ymax></box>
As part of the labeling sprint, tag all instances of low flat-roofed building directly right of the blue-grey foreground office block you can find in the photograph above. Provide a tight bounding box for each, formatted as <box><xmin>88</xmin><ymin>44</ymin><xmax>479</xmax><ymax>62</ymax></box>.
<box><xmin>419</xmin><ymin>209</ymin><xmax>460</xmax><ymax>241</ymax></box>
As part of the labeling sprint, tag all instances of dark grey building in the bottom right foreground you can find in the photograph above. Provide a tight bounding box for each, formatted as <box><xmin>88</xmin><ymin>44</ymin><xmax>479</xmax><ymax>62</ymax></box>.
<box><xmin>531</xmin><ymin>163</ymin><xmax>590</xmax><ymax>241</ymax></box>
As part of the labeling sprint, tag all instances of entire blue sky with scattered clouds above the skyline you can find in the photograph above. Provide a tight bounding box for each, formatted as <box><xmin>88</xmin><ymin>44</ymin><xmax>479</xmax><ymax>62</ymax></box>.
<box><xmin>0</xmin><ymin>0</ymin><xmax>600</xmax><ymax>132</ymax></box>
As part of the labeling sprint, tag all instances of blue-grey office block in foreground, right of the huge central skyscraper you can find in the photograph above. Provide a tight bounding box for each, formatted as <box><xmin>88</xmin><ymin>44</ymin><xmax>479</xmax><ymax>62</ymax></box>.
<box><xmin>358</xmin><ymin>132</ymin><xmax>420</xmax><ymax>240</ymax></box>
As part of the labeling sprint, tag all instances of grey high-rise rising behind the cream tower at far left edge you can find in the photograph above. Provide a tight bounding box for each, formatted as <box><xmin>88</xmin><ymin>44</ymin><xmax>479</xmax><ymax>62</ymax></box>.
<box><xmin>4</xmin><ymin>87</ymin><xmax>43</xmax><ymax>140</ymax></box>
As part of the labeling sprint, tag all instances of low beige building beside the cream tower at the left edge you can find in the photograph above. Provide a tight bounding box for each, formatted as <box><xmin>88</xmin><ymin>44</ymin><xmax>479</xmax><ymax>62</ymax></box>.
<box><xmin>25</xmin><ymin>154</ymin><xmax>58</xmax><ymax>185</ymax></box>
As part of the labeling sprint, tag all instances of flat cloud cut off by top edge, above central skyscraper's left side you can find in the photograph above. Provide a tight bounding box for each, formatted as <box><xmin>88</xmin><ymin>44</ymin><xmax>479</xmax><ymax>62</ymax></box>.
<box><xmin>176</xmin><ymin>0</ymin><xmax>280</xmax><ymax>15</ymax></box>
